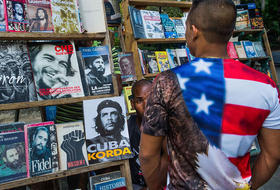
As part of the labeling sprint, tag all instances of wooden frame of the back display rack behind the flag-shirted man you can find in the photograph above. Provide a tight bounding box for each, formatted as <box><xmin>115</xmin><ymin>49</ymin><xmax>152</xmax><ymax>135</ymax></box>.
<box><xmin>122</xmin><ymin>0</ymin><xmax>279</xmax><ymax>86</ymax></box>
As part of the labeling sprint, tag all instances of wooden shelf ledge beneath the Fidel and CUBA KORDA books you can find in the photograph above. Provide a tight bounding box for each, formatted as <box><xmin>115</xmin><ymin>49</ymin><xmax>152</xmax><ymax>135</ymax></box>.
<box><xmin>0</xmin><ymin>160</ymin><xmax>128</xmax><ymax>189</ymax></box>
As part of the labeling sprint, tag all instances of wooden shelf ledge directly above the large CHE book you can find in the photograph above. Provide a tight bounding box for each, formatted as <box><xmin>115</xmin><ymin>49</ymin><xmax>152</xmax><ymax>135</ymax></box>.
<box><xmin>0</xmin><ymin>32</ymin><xmax>106</xmax><ymax>40</ymax></box>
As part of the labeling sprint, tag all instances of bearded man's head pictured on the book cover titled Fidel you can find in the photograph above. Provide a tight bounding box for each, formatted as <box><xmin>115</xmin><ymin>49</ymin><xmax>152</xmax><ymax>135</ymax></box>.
<box><xmin>32</xmin><ymin>127</ymin><xmax>49</xmax><ymax>155</ymax></box>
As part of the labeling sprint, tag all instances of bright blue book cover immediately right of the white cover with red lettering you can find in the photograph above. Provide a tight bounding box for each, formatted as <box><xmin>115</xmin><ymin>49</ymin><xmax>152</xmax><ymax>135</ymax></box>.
<box><xmin>160</xmin><ymin>14</ymin><xmax>178</xmax><ymax>38</ymax></box>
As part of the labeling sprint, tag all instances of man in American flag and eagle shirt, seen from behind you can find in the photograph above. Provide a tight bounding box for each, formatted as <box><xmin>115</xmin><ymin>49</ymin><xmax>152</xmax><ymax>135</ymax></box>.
<box><xmin>140</xmin><ymin>0</ymin><xmax>280</xmax><ymax>190</ymax></box>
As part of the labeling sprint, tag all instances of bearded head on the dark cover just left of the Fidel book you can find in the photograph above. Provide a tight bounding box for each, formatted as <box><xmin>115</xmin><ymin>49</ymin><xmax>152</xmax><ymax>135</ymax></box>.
<box><xmin>3</xmin><ymin>144</ymin><xmax>22</xmax><ymax>170</ymax></box>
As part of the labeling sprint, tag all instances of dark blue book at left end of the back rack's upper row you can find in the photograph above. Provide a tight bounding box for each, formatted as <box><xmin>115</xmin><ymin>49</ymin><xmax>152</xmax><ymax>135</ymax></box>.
<box><xmin>128</xmin><ymin>6</ymin><xmax>146</xmax><ymax>39</ymax></box>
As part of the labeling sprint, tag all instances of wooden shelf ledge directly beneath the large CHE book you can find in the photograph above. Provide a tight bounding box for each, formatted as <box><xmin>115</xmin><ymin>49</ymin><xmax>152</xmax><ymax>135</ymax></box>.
<box><xmin>0</xmin><ymin>94</ymin><xmax>114</xmax><ymax>110</ymax></box>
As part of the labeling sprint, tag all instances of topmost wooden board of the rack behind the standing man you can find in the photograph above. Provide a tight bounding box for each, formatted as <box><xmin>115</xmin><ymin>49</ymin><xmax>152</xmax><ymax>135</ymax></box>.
<box><xmin>129</xmin><ymin>0</ymin><xmax>192</xmax><ymax>9</ymax></box>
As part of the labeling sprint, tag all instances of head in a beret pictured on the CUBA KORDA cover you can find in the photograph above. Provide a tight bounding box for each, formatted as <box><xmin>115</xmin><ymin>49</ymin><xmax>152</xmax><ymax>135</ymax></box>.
<box><xmin>95</xmin><ymin>100</ymin><xmax>124</xmax><ymax>136</ymax></box>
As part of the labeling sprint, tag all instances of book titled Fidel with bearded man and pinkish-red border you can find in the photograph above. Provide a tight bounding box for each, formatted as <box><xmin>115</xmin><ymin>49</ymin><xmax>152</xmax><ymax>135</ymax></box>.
<box><xmin>24</xmin><ymin>121</ymin><xmax>59</xmax><ymax>177</ymax></box>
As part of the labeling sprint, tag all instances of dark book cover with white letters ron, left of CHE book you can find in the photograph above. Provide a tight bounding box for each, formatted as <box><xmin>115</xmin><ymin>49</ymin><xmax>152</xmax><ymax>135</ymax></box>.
<box><xmin>0</xmin><ymin>42</ymin><xmax>36</xmax><ymax>103</ymax></box>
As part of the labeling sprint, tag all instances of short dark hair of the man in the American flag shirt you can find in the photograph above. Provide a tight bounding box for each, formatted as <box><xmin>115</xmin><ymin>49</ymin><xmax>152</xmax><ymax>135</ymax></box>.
<box><xmin>187</xmin><ymin>0</ymin><xmax>236</xmax><ymax>43</ymax></box>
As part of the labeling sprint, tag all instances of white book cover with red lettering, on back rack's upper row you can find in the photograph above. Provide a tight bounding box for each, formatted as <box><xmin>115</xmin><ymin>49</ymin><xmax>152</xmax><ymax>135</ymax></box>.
<box><xmin>140</xmin><ymin>10</ymin><xmax>164</xmax><ymax>38</ymax></box>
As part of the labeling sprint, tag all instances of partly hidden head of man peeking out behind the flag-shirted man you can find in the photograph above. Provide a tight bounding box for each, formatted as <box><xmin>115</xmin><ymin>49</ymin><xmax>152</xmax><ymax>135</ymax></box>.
<box><xmin>130</xmin><ymin>79</ymin><xmax>152</xmax><ymax>118</ymax></box>
